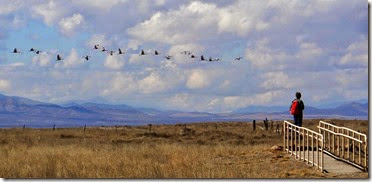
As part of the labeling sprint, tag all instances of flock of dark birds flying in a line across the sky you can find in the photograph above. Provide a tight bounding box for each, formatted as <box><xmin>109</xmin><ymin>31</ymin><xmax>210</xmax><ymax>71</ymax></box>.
<box><xmin>12</xmin><ymin>44</ymin><xmax>243</xmax><ymax>62</ymax></box>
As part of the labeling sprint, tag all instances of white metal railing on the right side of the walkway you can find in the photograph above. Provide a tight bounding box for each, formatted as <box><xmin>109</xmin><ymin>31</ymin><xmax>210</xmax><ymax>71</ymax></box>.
<box><xmin>318</xmin><ymin>121</ymin><xmax>368</xmax><ymax>171</ymax></box>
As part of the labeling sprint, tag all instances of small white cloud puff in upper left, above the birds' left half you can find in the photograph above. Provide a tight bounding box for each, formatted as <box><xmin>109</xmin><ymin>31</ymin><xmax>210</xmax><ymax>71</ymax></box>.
<box><xmin>58</xmin><ymin>13</ymin><xmax>84</xmax><ymax>36</ymax></box>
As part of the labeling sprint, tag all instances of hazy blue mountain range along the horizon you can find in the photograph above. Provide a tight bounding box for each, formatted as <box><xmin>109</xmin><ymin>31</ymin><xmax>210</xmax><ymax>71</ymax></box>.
<box><xmin>0</xmin><ymin>94</ymin><xmax>368</xmax><ymax>127</ymax></box>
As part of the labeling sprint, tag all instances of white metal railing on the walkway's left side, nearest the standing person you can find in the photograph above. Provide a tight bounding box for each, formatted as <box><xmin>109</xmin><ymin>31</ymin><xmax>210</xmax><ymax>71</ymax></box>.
<box><xmin>283</xmin><ymin>121</ymin><xmax>324</xmax><ymax>172</ymax></box>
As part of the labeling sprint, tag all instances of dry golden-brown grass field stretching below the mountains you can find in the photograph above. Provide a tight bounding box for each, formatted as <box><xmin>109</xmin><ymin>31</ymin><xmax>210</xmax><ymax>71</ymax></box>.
<box><xmin>0</xmin><ymin>120</ymin><xmax>368</xmax><ymax>178</ymax></box>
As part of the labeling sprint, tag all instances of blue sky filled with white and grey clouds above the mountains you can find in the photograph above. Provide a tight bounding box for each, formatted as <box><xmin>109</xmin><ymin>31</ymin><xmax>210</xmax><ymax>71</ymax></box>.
<box><xmin>0</xmin><ymin>0</ymin><xmax>368</xmax><ymax>113</ymax></box>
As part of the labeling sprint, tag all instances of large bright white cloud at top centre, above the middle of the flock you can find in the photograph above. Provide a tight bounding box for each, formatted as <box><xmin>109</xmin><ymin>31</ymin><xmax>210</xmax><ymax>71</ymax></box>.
<box><xmin>128</xmin><ymin>1</ymin><xmax>218</xmax><ymax>44</ymax></box>
